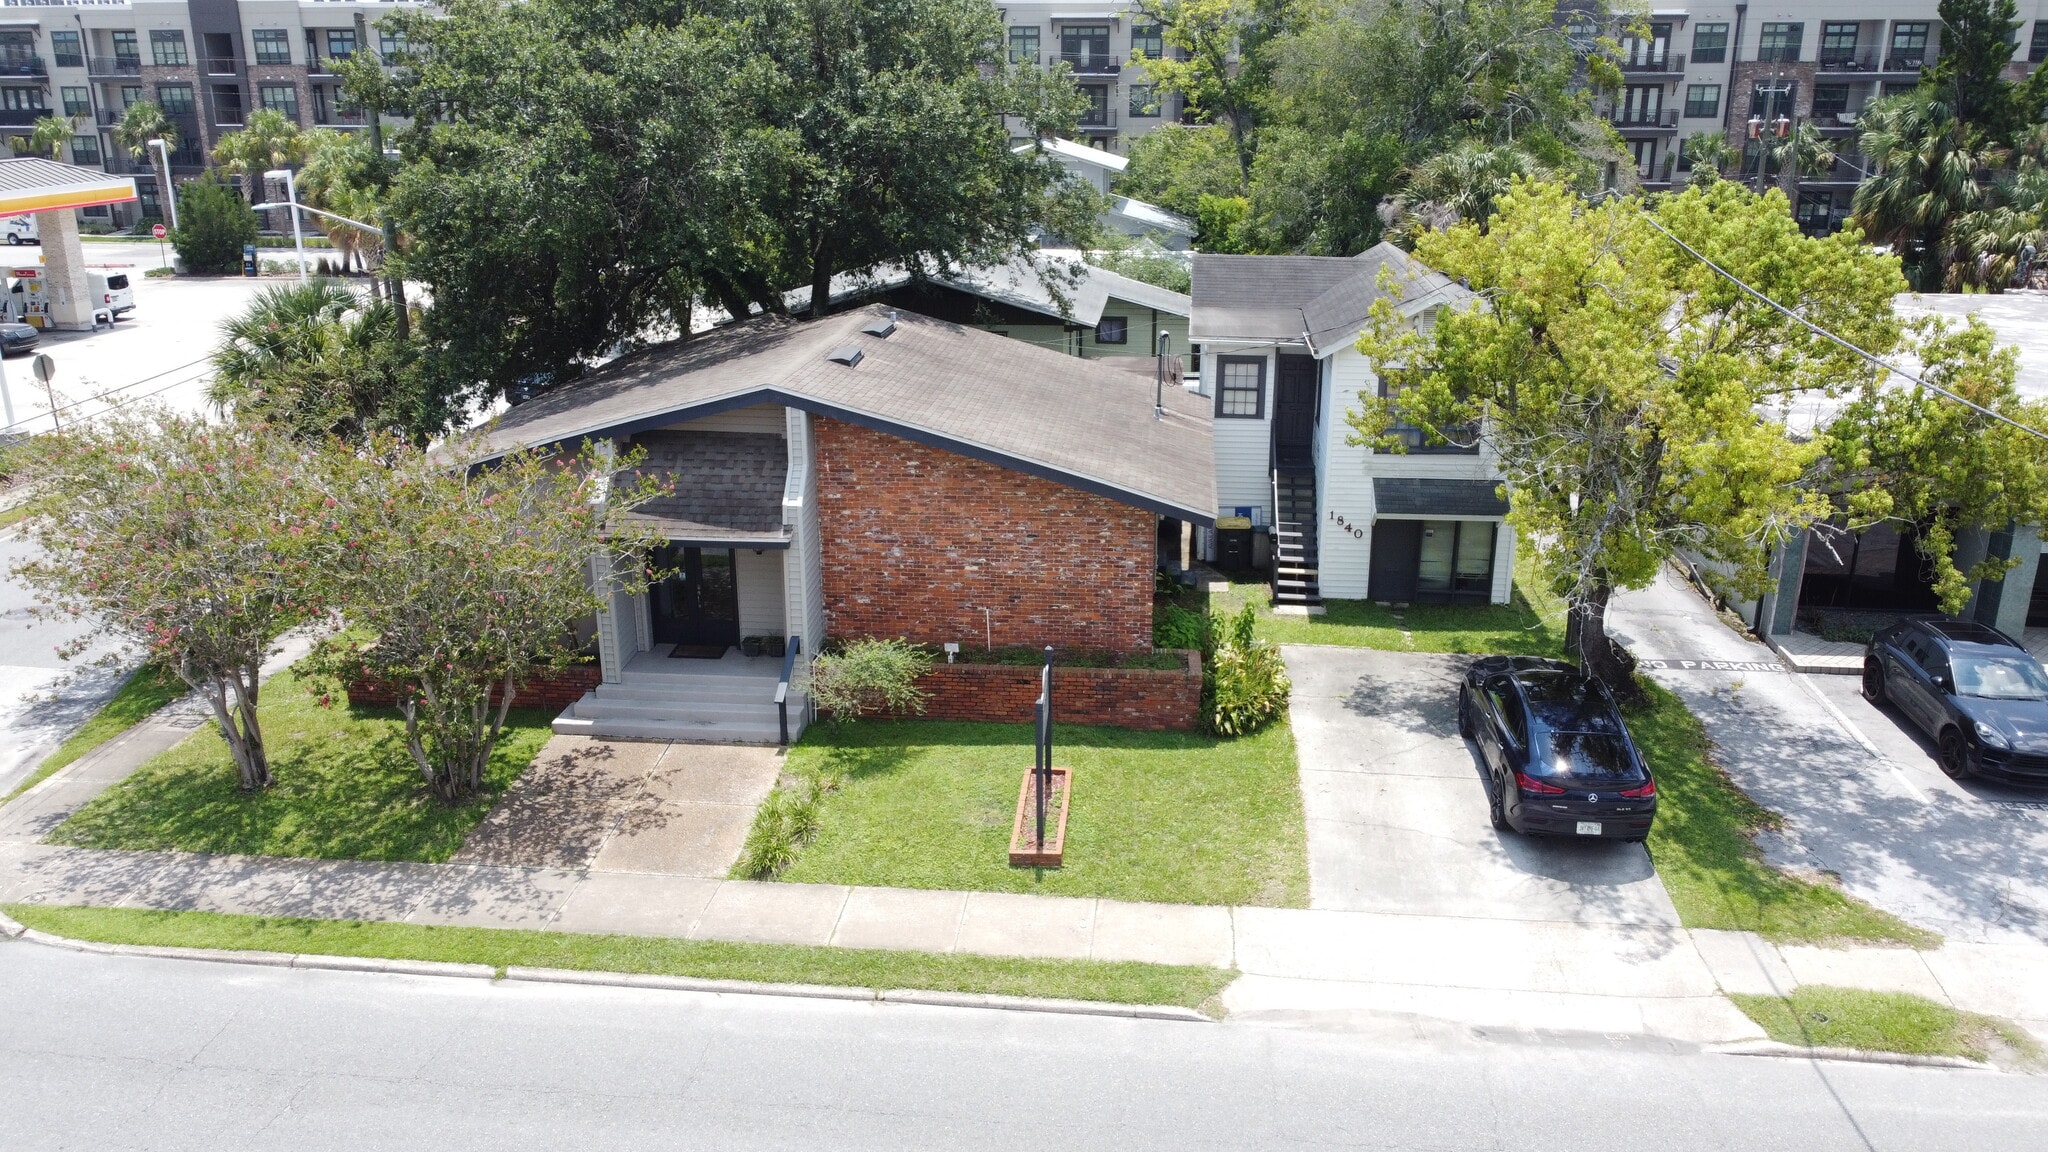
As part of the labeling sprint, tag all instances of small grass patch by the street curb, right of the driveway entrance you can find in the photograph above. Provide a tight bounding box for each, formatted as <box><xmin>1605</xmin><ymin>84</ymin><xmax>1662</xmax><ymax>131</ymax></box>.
<box><xmin>1731</xmin><ymin>984</ymin><xmax>2040</xmax><ymax>1062</ymax></box>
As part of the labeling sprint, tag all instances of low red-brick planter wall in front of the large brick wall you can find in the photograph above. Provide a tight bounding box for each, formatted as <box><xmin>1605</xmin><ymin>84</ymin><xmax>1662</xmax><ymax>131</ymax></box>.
<box><xmin>918</xmin><ymin>652</ymin><xmax>1202</xmax><ymax>732</ymax></box>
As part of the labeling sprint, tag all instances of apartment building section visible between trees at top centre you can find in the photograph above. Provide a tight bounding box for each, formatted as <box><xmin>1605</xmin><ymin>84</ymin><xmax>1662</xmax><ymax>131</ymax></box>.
<box><xmin>999</xmin><ymin>0</ymin><xmax>1182</xmax><ymax>154</ymax></box>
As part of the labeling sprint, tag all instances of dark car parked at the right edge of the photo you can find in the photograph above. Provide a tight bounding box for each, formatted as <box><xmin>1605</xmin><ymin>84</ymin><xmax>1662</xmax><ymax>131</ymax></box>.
<box><xmin>1864</xmin><ymin>619</ymin><xmax>2048</xmax><ymax>787</ymax></box>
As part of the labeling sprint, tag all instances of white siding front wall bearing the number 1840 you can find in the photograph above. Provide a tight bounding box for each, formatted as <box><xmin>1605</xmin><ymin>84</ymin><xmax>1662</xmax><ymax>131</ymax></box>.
<box><xmin>1318</xmin><ymin>346</ymin><xmax>1513</xmax><ymax>605</ymax></box>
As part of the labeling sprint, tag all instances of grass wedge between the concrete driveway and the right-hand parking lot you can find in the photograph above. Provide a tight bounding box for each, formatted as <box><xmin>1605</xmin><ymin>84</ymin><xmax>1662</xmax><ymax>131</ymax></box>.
<box><xmin>1628</xmin><ymin>681</ymin><xmax>1942</xmax><ymax>947</ymax></box>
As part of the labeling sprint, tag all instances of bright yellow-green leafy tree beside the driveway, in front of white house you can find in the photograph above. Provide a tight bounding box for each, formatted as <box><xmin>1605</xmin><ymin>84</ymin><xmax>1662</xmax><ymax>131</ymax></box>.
<box><xmin>1346</xmin><ymin>182</ymin><xmax>1905</xmax><ymax>691</ymax></box>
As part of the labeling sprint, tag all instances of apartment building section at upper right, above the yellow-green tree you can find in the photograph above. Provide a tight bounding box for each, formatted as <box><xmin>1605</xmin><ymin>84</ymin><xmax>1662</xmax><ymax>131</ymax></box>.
<box><xmin>1606</xmin><ymin>0</ymin><xmax>2048</xmax><ymax>234</ymax></box>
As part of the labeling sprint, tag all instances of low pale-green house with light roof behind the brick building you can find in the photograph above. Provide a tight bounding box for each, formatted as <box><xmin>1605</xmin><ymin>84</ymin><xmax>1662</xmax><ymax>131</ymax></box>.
<box><xmin>784</xmin><ymin>254</ymin><xmax>1192</xmax><ymax>371</ymax></box>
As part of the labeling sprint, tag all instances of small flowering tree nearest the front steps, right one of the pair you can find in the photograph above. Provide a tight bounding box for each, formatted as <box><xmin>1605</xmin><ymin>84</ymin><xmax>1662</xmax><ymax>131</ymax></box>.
<box><xmin>315</xmin><ymin>439</ymin><xmax>657</xmax><ymax>801</ymax></box>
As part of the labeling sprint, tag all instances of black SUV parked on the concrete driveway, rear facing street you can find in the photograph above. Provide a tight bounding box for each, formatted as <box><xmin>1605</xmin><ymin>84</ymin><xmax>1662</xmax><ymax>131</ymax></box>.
<box><xmin>1458</xmin><ymin>656</ymin><xmax>1657</xmax><ymax>842</ymax></box>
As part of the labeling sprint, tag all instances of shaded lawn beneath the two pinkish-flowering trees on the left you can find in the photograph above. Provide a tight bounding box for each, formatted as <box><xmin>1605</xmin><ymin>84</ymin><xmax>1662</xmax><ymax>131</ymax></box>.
<box><xmin>51</xmin><ymin>670</ymin><xmax>551</xmax><ymax>863</ymax></box>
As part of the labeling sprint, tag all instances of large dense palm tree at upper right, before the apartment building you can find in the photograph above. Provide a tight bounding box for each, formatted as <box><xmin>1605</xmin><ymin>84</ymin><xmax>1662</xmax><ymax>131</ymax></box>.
<box><xmin>1851</xmin><ymin>88</ymin><xmax>2005</xmax><ymax>289</ymax></box>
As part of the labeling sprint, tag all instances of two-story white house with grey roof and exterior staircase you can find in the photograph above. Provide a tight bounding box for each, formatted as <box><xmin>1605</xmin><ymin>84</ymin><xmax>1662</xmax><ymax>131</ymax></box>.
<box><xmin>1188</xmin><ymin>244</ymin><xmax>1516</xmax><ymax>613</ymax></box>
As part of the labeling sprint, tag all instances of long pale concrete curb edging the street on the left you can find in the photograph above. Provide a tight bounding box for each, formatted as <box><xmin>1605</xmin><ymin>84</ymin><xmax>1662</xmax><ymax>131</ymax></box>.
<box><xmin>0</xmin><ymin>914</ymin><xmax>1214</xmax><ymax>1023</ymax></box>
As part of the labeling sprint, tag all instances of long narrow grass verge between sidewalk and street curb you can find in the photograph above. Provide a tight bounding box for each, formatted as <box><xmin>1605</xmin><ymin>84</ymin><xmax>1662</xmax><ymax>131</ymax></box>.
<box><xmin>4</xmin><ymin>904</ymin><xmax>1237</xmax><ymax>1009</ymax></box>
